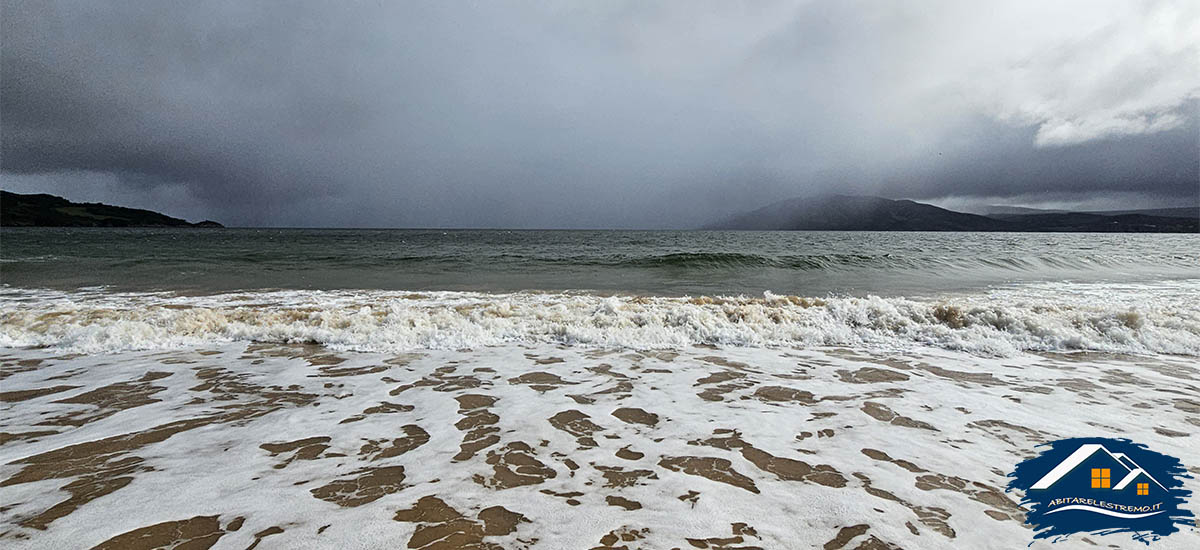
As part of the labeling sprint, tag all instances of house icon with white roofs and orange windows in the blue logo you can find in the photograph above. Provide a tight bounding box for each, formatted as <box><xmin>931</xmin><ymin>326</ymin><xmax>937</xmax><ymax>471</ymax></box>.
<box><xmin>1030</xmin><ymin>443</ymin><xmax>1166</xmax><ymax>501</ymax></box>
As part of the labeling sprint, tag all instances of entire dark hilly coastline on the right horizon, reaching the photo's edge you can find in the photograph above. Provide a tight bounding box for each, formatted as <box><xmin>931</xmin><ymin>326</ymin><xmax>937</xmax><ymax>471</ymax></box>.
<box><xmin>706</xmin><ymin>195</ymin><xmax>1200</xmax><ymax>233</ymax></box>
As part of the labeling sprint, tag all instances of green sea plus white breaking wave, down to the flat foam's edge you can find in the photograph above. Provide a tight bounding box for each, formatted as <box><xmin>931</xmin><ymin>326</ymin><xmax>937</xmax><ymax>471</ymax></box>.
<box><xmin>0</xmin><ymin>229</ymin><xmax>1200</xmax><ymax>355</ymax></box>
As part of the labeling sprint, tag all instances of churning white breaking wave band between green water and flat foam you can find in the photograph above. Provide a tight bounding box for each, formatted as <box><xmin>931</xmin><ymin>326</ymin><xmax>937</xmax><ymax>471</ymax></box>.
<box><xmin>0</xmin><ymin>280</ymin><xmax>1200</xmax><ymax>355</ymax></box>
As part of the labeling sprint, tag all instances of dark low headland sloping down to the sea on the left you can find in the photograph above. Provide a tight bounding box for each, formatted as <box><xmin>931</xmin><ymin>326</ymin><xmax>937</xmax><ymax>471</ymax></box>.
<box><xmin>0</xmin><ymin>191</ymin><xmax>224</xmax><ymax>227</ymax></box>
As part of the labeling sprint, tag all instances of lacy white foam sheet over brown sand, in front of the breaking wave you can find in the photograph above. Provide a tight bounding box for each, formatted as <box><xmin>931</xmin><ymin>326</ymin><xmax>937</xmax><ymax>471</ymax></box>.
<box><xmin>0</xmin><ymin>342</ymin><xmax>1200</xmax><ymax>550</ymax></box>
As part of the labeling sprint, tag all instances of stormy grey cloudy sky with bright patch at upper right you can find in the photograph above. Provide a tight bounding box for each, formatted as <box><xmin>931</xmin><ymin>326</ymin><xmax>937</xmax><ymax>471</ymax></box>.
<box><xmin>0</xmin><ymin>0</ymin><xmax>1200</xmax><ymax>228</ymax></box>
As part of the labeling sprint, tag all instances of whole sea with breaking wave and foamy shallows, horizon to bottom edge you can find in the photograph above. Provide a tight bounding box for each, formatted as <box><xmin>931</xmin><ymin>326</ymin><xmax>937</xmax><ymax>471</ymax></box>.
<box><xmin>0</xmin><ymin>228</ymin><xmax>1200</xmax><ymax>549</ymax></box>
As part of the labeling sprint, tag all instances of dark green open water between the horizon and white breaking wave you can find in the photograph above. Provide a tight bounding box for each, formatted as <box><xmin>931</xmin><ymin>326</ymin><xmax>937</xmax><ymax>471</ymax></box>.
<box><xmin>0</xmin><ymin>228</ymin><xmax>1200</xmax><ymax>295</ymax></box>
